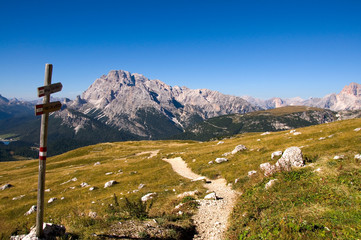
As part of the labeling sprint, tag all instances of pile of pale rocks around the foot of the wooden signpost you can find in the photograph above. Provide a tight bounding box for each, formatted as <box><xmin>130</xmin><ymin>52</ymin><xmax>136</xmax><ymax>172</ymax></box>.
<box><xmin>10</xmin><ymin>223</ymin><xmax>65</xmax><ymax>240</ymax></box>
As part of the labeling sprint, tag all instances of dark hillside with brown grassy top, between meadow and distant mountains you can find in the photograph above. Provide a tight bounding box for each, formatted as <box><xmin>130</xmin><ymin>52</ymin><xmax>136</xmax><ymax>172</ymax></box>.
<box><xmin>173</xmin><ymin>106</ymin><xmax>336</xmax><ymax>141</ymax></box>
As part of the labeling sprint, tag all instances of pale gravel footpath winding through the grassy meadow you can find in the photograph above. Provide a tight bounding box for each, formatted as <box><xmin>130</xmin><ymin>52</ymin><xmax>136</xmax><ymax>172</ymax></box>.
<box><xmin>163</xmin><ymin>157</ymin><xmax>238</xmax><ymax>240</ymax></box>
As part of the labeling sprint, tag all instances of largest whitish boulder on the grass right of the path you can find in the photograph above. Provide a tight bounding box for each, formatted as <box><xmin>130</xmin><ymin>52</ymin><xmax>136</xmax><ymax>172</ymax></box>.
<box><xmin>275</xmin><ymin>147</ymin><xmax>304</xmax><ymax>171</ymax></box>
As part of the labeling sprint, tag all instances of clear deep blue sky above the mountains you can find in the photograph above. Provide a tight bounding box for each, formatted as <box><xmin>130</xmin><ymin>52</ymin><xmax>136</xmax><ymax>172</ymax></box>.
<box><xmin>0</xmin><ymin>0</ymin><xmax>361</xmax><ymax>99</ymax></box>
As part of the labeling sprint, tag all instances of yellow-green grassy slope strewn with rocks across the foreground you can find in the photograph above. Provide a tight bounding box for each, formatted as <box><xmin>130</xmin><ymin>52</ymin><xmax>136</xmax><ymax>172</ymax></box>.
<box><xmin>0</xmin><ymin>119</ymin><xmax>361</xmax><ymax>239</ymax></box>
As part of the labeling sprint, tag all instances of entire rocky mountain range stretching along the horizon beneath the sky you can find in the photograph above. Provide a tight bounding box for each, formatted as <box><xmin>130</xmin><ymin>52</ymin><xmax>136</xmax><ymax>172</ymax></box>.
<box><xmin>0</xmin><ymin>70</ymin><xmax>361</xmax><ymax>158</ymax></box>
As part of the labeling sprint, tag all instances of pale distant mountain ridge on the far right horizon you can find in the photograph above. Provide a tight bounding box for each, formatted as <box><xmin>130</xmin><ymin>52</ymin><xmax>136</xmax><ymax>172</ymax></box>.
<box><xmin>242</xmin><ymin>82</ymin><xmax>361</xmax><ymax>111</ymax></box>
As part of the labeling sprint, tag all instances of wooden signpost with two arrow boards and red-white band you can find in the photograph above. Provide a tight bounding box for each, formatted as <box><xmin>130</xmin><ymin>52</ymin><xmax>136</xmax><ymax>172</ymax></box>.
<box><xmin>35</xmin><ymin>64</ymin><xmax>63</xmax><ymax>238</ymax></box>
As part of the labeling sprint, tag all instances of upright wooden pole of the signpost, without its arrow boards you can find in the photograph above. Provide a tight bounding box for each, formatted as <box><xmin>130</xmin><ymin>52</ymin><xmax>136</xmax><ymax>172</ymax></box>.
<box><xmin>36</xmin><ymin>64</ymin><xmax>53</xmax><ymax>238</ymax></box>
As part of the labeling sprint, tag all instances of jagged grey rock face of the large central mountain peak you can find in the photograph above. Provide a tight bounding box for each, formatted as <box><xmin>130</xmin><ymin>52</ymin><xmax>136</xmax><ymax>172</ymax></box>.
<box><xmin>63</xmin><ymin>70</ymin><xmax>259</xmax><ymax>137</ymax></box>
